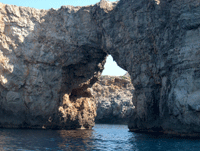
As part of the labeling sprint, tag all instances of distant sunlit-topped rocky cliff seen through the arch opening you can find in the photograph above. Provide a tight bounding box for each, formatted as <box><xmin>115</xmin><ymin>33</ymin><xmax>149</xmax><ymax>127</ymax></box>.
<box><xmin>92</xmin><ymin>76</ymin><xmax>135</xmax><ymax>124</ymax></box>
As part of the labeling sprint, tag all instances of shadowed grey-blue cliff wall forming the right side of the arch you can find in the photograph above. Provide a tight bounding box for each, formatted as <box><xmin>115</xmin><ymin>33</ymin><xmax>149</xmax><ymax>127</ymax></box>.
<box><xmin>102</xmin><ymin>0</ymin><xmax>200</xmax><ymax>136</ymax></box>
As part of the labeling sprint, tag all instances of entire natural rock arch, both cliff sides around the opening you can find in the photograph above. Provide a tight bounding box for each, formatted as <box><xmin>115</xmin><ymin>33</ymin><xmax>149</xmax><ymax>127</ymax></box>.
<box><xmin>0</xmin><ymin>0</ymin><xmax>200</xmax><ymax>135</ymax></box>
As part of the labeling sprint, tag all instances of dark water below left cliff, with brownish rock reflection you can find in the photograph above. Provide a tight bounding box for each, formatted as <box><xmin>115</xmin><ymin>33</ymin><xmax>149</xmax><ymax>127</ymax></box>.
<box><xmin>0</xmin><ymin>129</ymin><xmax>93</xmax><ymax>151</ymax></box>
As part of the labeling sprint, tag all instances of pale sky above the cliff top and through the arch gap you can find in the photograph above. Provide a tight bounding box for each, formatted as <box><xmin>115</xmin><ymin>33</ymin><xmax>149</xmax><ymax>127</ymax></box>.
<box><xmin>0</xmin><ymin>0</ymin><xmax>126</xmax><ymax>76</ymax></box>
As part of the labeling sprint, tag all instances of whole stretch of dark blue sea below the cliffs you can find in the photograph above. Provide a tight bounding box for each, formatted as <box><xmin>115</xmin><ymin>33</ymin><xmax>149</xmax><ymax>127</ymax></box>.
<box><xmin>0</xmin><ymin>124</ymin><xmax>200</xmax><ymax>151</ymax></box>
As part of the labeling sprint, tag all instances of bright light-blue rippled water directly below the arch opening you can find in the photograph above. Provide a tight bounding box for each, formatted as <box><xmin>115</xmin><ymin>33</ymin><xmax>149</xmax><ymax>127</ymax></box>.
<box><xmin>92</xmin><ymin>124</ymin><xmax>136</xmax><ymax>151</ymax></box>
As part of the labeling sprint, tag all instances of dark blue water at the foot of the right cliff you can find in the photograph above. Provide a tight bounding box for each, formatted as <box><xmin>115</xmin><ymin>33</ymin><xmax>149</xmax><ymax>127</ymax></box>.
<box><xmin>129</xmin><ymin>132</ymin><xmax>200</xmax><ymax>151</ymax></box>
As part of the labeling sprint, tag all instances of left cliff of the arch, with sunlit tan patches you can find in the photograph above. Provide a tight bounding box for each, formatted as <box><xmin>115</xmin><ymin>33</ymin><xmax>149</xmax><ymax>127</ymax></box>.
<box><xmin>0</xmin><ymin>4</ymin><xmax>107</xmax><ymax>129</ymax></box>
